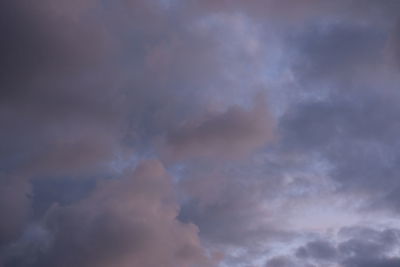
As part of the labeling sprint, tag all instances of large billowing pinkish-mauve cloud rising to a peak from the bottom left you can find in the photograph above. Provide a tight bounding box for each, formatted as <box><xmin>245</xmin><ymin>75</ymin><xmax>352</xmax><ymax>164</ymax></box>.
<box><xmin>2</xmin><ymin>160</ymin><xmax>216</xmax><ymax>267</ymax></box>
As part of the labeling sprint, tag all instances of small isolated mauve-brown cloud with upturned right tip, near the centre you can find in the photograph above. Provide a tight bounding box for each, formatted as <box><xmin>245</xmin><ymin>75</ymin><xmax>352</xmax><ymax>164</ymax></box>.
<box><xmin>162</xmin><ymin>94</ymin><xmax>273</xmax><ymax>159</ymax></box>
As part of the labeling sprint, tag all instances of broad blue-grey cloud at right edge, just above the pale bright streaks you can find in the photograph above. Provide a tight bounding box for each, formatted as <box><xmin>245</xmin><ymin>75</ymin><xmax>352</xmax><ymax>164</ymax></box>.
<box><xmin>282</xmin><ymin>80</ymin><xmax>399</xmax><ymax>210</ymax></box>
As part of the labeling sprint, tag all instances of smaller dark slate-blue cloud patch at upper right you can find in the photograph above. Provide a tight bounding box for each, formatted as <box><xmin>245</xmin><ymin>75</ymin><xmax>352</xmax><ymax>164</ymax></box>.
<box><xmin>289</xmin><ymin>22</ymin><xmax>389</xmax><ymax>86</ymax></box>
